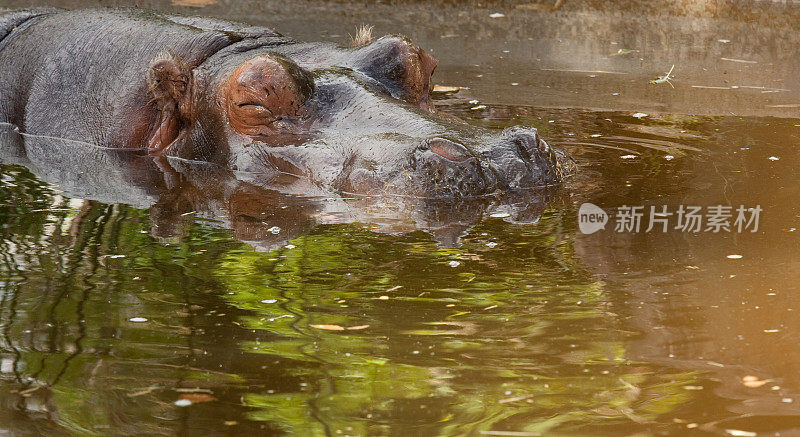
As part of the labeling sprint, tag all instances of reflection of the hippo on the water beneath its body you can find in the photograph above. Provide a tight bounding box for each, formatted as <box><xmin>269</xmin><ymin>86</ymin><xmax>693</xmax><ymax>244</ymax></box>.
<box><xmin>0</xmin><ymin>125</ymin><xmax>554</xmax><ymax>250</ymax></box>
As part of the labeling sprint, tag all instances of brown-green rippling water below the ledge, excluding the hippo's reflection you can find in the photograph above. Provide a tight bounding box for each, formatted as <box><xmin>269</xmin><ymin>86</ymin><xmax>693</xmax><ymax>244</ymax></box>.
<box><xmin>0</xmin><ymin>1</ymin><xmax>800</xmax><ymax>436</ymax></box>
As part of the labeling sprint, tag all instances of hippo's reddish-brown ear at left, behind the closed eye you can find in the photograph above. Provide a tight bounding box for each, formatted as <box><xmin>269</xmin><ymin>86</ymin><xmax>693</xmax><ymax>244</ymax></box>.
<box><xmin>147</xmin><ymin>53</ymin><xmax>192</xmax><ymax>152</ymax></box>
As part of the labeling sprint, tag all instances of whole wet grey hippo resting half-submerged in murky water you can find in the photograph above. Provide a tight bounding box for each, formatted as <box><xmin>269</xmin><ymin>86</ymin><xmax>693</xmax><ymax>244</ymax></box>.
<box><xmin>0</xmin><ymin>9</ymin><xmax>573</xmax><ymax>198</ymax></box>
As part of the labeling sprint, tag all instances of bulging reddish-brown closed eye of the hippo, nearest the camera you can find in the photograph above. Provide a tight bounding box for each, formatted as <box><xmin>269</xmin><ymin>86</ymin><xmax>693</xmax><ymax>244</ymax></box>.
<box><xmin>222</xmin><ymin>56</ymin><xmax>314</xmax><ymax>137</ymax></box>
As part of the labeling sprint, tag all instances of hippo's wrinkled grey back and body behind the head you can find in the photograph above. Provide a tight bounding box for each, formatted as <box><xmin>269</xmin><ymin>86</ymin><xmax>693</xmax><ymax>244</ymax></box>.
<box><xmin>0</xmin><ymin>9</ymin><xmax>290</xmax><ymax>147</ymax></box>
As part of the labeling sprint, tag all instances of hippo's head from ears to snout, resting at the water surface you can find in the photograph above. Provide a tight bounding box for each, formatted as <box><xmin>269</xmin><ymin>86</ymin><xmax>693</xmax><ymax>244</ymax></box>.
<box><xmin>150</xmin><ymin>36</ymin><xmax>571</xmax><ymax>198</ymax></box>
